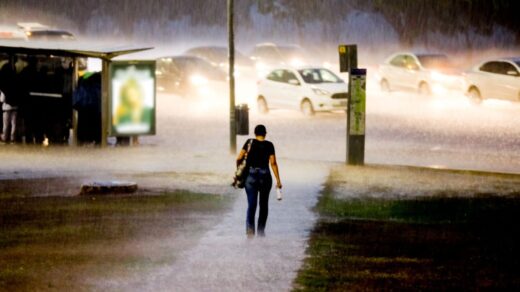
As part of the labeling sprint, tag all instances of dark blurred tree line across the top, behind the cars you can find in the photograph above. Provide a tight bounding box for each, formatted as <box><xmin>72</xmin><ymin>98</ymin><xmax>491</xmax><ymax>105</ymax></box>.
<box><xmin>0</xmin><ymin>0</ymin><xmax>520</xmax><ymax>45</ymax></box>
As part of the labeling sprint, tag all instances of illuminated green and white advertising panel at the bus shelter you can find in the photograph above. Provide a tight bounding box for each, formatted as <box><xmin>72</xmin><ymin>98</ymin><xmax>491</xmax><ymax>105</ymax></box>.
<box><xmin>109</xmin><ymin>61</ymin><xmax>155</xmax><ymax>137</ymax></box>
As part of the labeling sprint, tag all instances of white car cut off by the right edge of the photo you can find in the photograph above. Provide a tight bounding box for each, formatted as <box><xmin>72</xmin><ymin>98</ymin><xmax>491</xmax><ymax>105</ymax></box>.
<box><xmin>465</xmin><ymin>57</ymin><xmax>520</xmax><ymax>103</ymax></box>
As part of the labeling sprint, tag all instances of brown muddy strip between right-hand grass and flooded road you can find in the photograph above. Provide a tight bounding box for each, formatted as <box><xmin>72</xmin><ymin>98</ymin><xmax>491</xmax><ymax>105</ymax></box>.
<box><xmin>329</xmin><ymin>166</ymin><xmax>520</xmax><ymax>199</ymax></box>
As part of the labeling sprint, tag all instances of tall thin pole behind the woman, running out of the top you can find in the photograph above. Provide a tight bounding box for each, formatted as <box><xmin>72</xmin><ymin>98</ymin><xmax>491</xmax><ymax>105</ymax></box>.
<box><xmin>227</xmin><ymin>0</ymin><xmax>237</xmax><ymax>154</ymax></box>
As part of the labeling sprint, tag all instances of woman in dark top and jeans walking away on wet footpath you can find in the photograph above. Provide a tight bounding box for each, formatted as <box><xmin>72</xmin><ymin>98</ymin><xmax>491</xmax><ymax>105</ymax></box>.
<box><xmin>237</xmin><ymin>125</ymin><xmax>282</xmax><ymax>237</ymax></box>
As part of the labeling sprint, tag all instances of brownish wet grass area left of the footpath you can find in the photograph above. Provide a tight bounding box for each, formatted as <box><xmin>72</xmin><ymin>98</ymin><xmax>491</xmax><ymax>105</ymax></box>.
<box><xmin>0</xmin><ymin>191</ymin><xmax>232</xmax><ymax>291</ymax></box>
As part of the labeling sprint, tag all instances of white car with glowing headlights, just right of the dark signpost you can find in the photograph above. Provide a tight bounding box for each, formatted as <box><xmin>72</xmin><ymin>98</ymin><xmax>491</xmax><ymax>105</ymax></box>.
<box><xmin>378</xmin><ymin>53</ymin><xmax>462</xmax><ymax>95</ymax></box>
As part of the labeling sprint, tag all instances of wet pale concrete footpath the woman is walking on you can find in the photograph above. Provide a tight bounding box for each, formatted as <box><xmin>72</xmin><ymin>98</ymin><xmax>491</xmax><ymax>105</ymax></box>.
<box><xmin>98</xmin><ymin>161</ymin><xmax>330</xmax><ymax>291</ymax></box>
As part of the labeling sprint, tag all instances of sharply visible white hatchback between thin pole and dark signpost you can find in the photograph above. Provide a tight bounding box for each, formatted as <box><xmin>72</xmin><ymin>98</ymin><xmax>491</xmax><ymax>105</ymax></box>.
<box><xmin>257</xmin><ymin>67</ymin><xmax>348</xmax><ymax>115</ymax></box>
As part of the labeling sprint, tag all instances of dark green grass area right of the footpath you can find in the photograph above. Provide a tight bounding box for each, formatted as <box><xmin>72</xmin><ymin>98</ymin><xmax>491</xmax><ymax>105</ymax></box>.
<box><xmin>294</xmin><ymin>187</ymin><xmax>520</xmax><ymax>291</ymax></box>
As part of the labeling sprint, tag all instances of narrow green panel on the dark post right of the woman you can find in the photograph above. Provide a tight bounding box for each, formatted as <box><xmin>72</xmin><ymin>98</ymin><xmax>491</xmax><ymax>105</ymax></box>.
<box><xmin>349</xmin><ymin>73</ymin><xmax>366</xmax><ymax>135</ymax></box>
